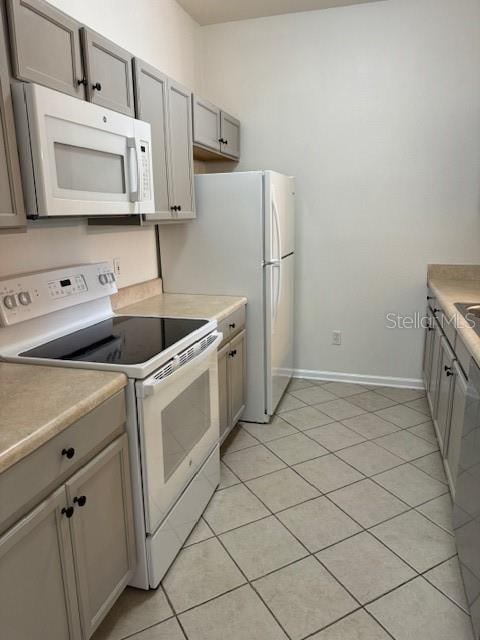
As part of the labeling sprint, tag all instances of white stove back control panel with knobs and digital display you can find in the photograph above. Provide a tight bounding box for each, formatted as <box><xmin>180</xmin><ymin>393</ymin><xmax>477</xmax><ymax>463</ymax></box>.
<box><xmin>0</xmin><ymin>262</ymin><xmax>117</xmax><ymax>327</ymax></box>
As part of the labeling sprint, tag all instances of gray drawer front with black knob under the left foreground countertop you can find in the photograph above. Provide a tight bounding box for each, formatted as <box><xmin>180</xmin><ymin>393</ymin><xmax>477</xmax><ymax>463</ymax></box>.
<box><xmin>0</xmin><ymin>391</ymin><xmax>126</xmax><ymax>532</ymax></box>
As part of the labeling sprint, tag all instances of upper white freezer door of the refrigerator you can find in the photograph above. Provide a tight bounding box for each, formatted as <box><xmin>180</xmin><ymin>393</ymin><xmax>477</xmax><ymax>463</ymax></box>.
<box><xmin>264</xmin><ymin>171</ymin><xmax>295</xmax><ymax>263</ymax></box>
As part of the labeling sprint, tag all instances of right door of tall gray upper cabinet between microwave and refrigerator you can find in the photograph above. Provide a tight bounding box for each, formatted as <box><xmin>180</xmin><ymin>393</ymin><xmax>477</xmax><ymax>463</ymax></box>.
<box><xmin>168</xmin><ymin>80</ymin><xmax>195</xmax><ymax>219</ymax></box>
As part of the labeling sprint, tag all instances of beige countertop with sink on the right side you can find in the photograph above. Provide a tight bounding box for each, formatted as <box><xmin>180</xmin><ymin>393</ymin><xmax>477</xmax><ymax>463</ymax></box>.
<box><xmin>427</xmin><ymin>265</ymin><xmax>480</xmax><ymax>366</ymax></box>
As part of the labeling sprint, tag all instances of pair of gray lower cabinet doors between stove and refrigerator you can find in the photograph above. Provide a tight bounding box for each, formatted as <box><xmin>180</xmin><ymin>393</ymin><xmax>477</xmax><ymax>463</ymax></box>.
<box><xmin>218</xmin><ymin>330</ymin><xmax>246</xmax><ymax>440</ymax></box>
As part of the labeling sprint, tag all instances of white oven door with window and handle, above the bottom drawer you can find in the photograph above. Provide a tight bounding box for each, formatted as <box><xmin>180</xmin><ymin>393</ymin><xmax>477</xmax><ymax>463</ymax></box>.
<box><xmin>136</xmin><ymin>332</ymin><xmax>222</xmax><ymax>534</ymax></box>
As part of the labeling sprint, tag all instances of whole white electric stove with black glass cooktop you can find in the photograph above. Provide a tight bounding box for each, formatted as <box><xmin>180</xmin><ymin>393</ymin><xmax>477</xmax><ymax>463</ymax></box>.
<box><xmin>0</xmin><ymin>263</ymin><xmax>222</xmax><ymax>589</ymax></box>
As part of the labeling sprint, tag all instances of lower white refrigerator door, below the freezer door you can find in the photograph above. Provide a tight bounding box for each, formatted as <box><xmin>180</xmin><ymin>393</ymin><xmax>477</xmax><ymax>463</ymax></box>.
<box><xmin>264</xmin><ymin>253</ymin><xmax>295</xmax><ymax>416</ymax></box>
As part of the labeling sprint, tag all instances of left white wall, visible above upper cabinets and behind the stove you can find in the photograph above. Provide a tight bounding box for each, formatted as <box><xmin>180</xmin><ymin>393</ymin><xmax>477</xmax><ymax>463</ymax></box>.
<box><xmin>0</xmin><ymin>0</ymin><xmax>200</xmax><ymax>286</ymax></box>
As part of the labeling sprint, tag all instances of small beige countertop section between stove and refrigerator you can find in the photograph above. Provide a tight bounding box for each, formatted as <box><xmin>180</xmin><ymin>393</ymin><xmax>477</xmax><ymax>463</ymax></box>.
<box><xmin>116</xmin><ymin>293</ymin><xmax>247</xmax><ymax>322</ymax></box>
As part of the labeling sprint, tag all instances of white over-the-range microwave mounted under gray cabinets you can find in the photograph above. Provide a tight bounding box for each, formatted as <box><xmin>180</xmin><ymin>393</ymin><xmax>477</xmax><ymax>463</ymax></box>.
<box><xmin>13</xmin><ymin>82</ymin><xmax>155</xmax><ymax>218</ymax></box>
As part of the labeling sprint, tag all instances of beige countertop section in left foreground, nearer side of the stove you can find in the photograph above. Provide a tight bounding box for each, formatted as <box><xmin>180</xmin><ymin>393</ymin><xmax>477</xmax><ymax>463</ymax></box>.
<box><xmin>0</xmin><ymin>362</ymin><xmax>127</xmax><ymax>473</ymax></box>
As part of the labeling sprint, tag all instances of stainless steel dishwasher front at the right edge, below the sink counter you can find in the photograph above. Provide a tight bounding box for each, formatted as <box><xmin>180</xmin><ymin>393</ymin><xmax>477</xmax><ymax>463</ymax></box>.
<box><xmin>453</xmin><ymin>360</ymin><xmax>480</xmax><ymax>640</ymax></box>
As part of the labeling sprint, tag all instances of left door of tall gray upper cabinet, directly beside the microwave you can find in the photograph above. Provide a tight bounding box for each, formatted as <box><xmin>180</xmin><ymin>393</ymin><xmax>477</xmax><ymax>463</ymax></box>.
<box><xmin>133</xmin><ymin>58</ymin><xmax>172</xmax><ymax>220</ymax></box>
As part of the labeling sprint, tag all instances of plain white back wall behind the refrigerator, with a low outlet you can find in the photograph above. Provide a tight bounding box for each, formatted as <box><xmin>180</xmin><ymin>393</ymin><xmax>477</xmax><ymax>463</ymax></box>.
<box><xmin>202</xmin><ymin>0</ymin><xmax>480</xmax><ymax>379</ymax></box>
